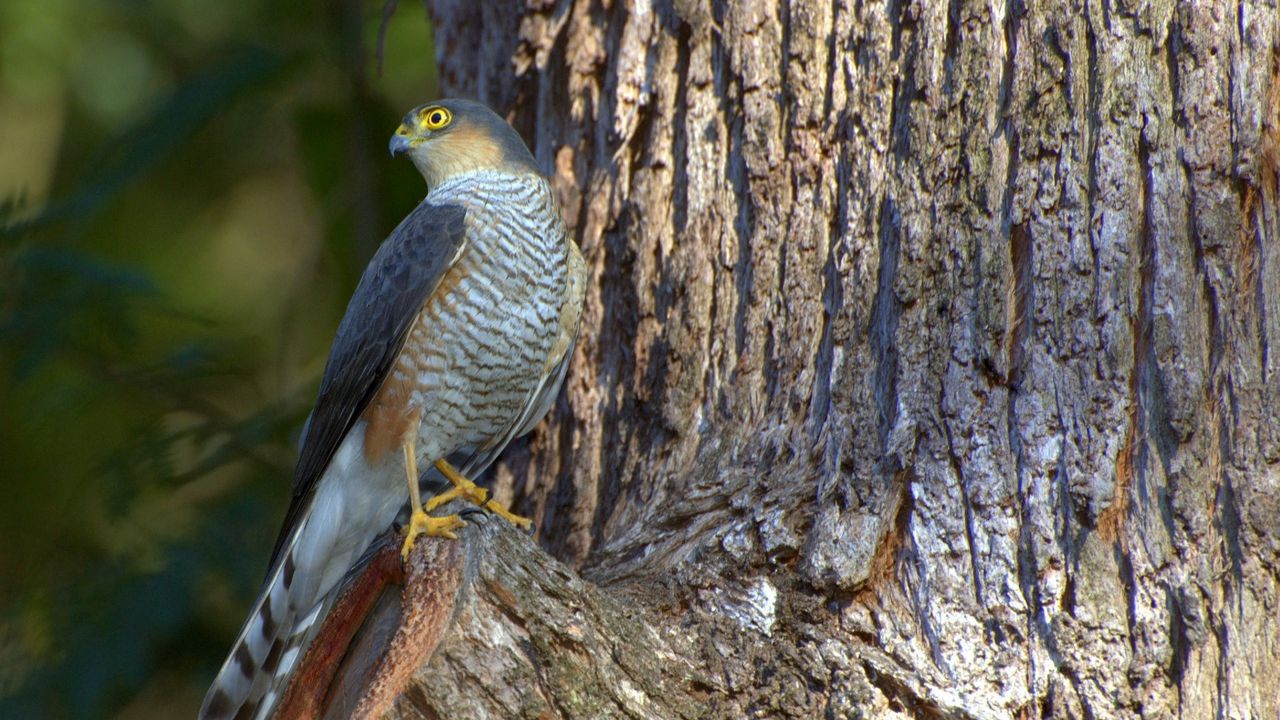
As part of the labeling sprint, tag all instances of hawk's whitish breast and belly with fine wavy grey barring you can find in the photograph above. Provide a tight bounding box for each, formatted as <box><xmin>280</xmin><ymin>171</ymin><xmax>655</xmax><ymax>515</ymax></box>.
<box><xmin>381</xmin><ymin>173</ymin><xmax>577</xmax><ymax>474</ymax></box>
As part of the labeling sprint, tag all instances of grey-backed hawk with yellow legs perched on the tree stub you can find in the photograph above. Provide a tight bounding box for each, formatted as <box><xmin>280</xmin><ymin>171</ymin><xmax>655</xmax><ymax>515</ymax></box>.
<box><xmin>200</xmin><ymin>99</ymin><xmax>586</xmax><ymax>720</ymax></box>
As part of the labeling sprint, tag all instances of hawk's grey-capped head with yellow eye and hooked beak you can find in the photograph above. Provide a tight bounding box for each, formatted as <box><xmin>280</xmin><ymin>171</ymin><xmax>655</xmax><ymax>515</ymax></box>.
<box><xmin>390</xmin><ymin>100</ymin><xmax>538</xmax><ymax>188</ymax></box>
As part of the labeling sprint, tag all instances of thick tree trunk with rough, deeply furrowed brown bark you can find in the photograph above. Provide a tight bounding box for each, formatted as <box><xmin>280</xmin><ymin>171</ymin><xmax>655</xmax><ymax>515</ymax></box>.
<box><xmin>332</xmin><ymin>0</ymin><xmax>1280</xmax><ymax>719</ymax></box>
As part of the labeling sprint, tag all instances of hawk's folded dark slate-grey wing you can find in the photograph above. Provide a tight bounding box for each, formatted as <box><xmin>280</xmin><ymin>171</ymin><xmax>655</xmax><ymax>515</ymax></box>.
<box><xmin>270</xmin><ymin>201</ymin><xmax>466</xmax><ymax>568</ymax></box>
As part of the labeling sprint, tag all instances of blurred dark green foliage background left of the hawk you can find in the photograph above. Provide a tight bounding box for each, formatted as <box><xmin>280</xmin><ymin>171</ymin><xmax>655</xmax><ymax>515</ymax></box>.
<box><xmin>0</xmin><ymin>0</ymin><xmax>436</xmax><ymax>719</ymax></box>
